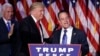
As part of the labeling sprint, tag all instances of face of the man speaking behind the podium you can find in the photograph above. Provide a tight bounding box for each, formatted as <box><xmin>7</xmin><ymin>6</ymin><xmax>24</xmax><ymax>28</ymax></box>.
<box><xmin>59</xmin><ymin>12</ymin><xmax>70</xmax><ymax>28</ymax></box>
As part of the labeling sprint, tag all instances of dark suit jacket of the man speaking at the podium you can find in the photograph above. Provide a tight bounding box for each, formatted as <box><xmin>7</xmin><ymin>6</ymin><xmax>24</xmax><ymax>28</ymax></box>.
<box><xmin>50</xmin><ymin>28</ymin><xmax>89</xmax><ymax>56</ymax></box>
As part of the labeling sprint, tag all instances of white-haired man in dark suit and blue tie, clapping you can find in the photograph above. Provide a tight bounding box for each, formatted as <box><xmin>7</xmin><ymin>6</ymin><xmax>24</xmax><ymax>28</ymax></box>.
<box><xmin>0</xmin><ymin>3</ymin><xmax>18</xmax><ymax>56</ymax></box>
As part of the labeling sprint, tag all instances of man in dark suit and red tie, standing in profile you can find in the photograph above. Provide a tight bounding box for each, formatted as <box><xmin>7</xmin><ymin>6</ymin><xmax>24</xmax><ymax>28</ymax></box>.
<box><xmin>19</xmin><ymin>2</ymin><xmax>44</xmax><ymax>56</ymax></box>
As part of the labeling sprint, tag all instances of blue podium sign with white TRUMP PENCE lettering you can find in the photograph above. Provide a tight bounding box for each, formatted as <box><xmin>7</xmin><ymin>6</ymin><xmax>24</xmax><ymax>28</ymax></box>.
<box><xmin>28</xmin><ymin>44</ymin><xmax>81</xmax><ymax>56</ymax></box>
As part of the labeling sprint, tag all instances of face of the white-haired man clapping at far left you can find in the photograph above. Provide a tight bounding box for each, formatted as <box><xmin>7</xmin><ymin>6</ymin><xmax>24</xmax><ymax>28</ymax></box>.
<box><xmin>3</xmin><ymin>7</ymin><xmax>13</xmax><ymax>20</ymax></box>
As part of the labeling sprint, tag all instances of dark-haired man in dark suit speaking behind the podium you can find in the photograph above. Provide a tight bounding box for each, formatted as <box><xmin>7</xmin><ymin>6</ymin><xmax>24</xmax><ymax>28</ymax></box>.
<box><xmin>50</xmin><ymin>10</ymin><xmax>89</xmax><ymax>56</ymax></box>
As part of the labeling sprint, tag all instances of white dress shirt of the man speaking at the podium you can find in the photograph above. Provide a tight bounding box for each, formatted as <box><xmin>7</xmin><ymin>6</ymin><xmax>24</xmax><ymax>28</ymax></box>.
<box><xmin>60</xmin><ymin>26</ymin><xmax>73</xmax><ymax>44</ymax></box>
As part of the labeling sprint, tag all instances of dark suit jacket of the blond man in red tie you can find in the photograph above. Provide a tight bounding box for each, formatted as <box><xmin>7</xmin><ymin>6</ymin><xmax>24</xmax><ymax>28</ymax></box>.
<box><xmin>19</xmin><ymin>16</ymin><xmax>41</xmax><ymax>56</ymax></box>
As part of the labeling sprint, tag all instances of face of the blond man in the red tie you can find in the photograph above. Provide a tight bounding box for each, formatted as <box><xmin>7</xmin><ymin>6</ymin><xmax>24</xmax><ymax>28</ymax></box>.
<box><xmin>34</xmin><ymin>7</ymin><xmax>44</xmax><ymax>20</ymax></box>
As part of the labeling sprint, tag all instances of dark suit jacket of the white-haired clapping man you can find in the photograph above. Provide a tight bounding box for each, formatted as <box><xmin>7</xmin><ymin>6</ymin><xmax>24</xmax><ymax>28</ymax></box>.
<box><xmin>0</xmin><ymin>18</ymin><xmax>18</xmax><ymax>56</ymax></box>
